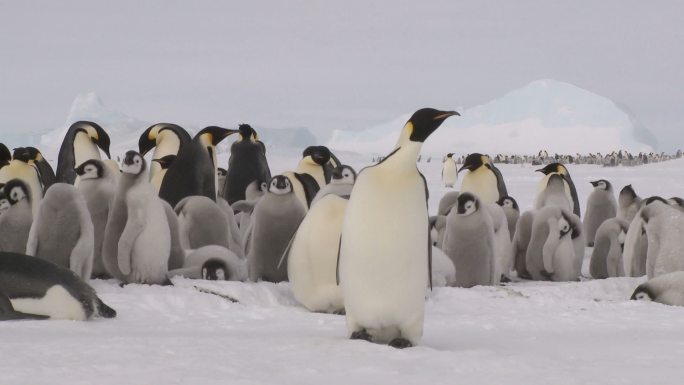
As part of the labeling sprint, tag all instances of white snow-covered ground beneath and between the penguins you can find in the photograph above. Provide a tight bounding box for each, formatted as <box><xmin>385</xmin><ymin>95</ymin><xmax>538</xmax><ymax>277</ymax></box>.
<box><xmin>0</xmin><ymin>153</ymin><xmax>684</xmax><ymax>385</ymax></box>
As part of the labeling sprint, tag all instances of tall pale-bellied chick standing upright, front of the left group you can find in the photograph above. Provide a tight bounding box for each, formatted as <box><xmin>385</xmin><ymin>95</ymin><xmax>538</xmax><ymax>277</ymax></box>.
<box><xmin>102</xmin><ymin>151</ymin><xmax>171</xmax><ymax>284</ymax></box>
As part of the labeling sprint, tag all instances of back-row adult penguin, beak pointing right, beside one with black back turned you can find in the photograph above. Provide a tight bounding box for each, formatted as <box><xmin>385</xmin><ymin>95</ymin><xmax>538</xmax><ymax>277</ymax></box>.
<box><xmin>159</xmin><ymin>126</ymin><xmax>237</xmax><ymax>207</ymax></box>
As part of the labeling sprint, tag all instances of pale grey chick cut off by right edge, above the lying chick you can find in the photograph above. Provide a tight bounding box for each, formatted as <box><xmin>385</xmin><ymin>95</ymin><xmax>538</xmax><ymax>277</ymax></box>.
<box><xmin>640</xmin><ymin>197</ymin><xmax>684</xmax><ymax>278</ymax></box>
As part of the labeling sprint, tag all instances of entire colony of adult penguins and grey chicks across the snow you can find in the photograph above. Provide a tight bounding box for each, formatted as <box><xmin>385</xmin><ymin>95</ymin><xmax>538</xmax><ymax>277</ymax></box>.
<box><xmin>0</xmin><ymin>112</ymin><xmax>684</xmax><ymax>348</ymax></box>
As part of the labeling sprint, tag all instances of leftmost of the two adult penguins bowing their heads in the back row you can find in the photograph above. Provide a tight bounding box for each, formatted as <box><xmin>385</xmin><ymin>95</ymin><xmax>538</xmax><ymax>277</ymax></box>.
<box><xmin>55</xmin><ymin>121</ymin><xmax>111</xmax><ymax>184</ymax></box>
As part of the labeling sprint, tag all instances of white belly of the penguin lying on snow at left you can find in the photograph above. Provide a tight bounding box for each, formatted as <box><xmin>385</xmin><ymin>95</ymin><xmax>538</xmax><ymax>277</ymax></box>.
<box><xmin>11</xmin><ymin>285</ymin><xmax>86</xmax><ymax>321</ymax></box>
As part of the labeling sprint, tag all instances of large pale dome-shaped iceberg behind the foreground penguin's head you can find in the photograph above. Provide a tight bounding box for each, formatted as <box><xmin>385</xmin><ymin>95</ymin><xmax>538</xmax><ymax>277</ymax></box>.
<box><xmin>328</xmin><ymin>79</ymin><xmax>657</xmax><ymax>154</ymax></box>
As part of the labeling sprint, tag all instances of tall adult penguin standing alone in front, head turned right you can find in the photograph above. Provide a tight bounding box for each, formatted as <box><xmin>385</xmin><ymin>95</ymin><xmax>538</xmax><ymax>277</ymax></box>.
<box><xmin>339</xmin><ymin>108</ymin><xmax>458</xmax><ymax>348</ymax></box>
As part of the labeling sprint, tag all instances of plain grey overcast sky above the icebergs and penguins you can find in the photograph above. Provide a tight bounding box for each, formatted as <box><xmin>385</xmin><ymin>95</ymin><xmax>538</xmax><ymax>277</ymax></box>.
<box><xmin>0</xmin><ymin>0</ymin><xmax>684</xmax><ymax>150</ymax></box>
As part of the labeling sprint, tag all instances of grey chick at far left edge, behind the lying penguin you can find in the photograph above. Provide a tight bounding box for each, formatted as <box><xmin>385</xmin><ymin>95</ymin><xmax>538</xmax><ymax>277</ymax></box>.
<box><xmin>0</xmin><ymin>179</ymin><xmax>33</xmax><ymax>253</ymax></box>
